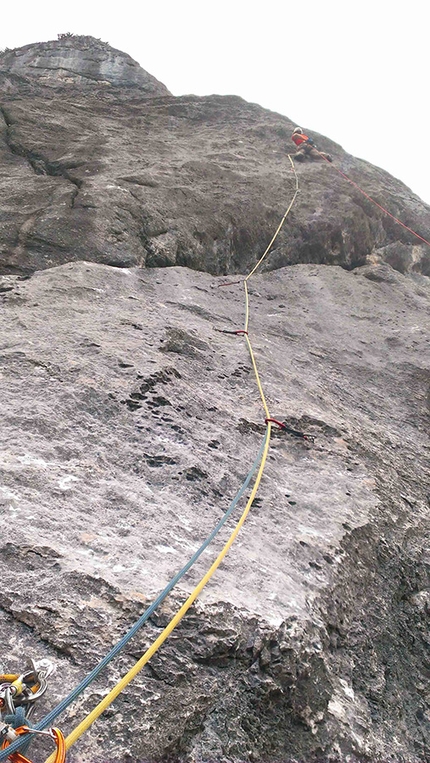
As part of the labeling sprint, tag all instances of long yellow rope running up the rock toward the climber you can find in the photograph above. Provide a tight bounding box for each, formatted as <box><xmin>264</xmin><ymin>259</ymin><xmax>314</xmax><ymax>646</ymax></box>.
<box><xmin>45</xmin><ymin>155</ymin><xmax>299</xmax><ymax>763</ymax></box>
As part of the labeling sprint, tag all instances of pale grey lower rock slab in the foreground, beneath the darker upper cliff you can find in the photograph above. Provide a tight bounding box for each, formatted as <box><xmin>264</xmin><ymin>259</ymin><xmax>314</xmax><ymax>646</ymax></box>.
<box><xmin>0</xmin><ymin>262</ymin><xmax>430</xmax><ymax>763</ymax></box>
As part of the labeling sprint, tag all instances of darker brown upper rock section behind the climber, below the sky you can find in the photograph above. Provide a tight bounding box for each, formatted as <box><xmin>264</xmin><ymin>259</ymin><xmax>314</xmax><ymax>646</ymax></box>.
<box><xmin>0</xmin><ymin>38</ymin><xmax>430</xmax><ymax>274</ymax></box>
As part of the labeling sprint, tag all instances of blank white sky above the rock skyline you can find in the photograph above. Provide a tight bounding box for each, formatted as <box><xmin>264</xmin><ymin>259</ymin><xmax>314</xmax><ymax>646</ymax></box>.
<box><xmin>0</xmin><ymin>0</ymin><xmax>430</xmax><ymax>203</ymax></box>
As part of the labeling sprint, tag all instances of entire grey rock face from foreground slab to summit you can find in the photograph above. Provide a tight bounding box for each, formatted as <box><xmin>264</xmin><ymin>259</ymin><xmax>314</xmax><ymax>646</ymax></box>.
<box><xmin>0</xmin><ymin>35</ymin><xmax>430</xmax><ymax>763</ymax></box>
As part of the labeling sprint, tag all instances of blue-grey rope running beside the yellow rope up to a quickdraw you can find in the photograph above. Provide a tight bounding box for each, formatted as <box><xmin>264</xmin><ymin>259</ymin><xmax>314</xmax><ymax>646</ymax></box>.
<box><xmin>0</xmin><ymin>429</ymin><xmax>268</xmax><ymax>761</ymax></box>
